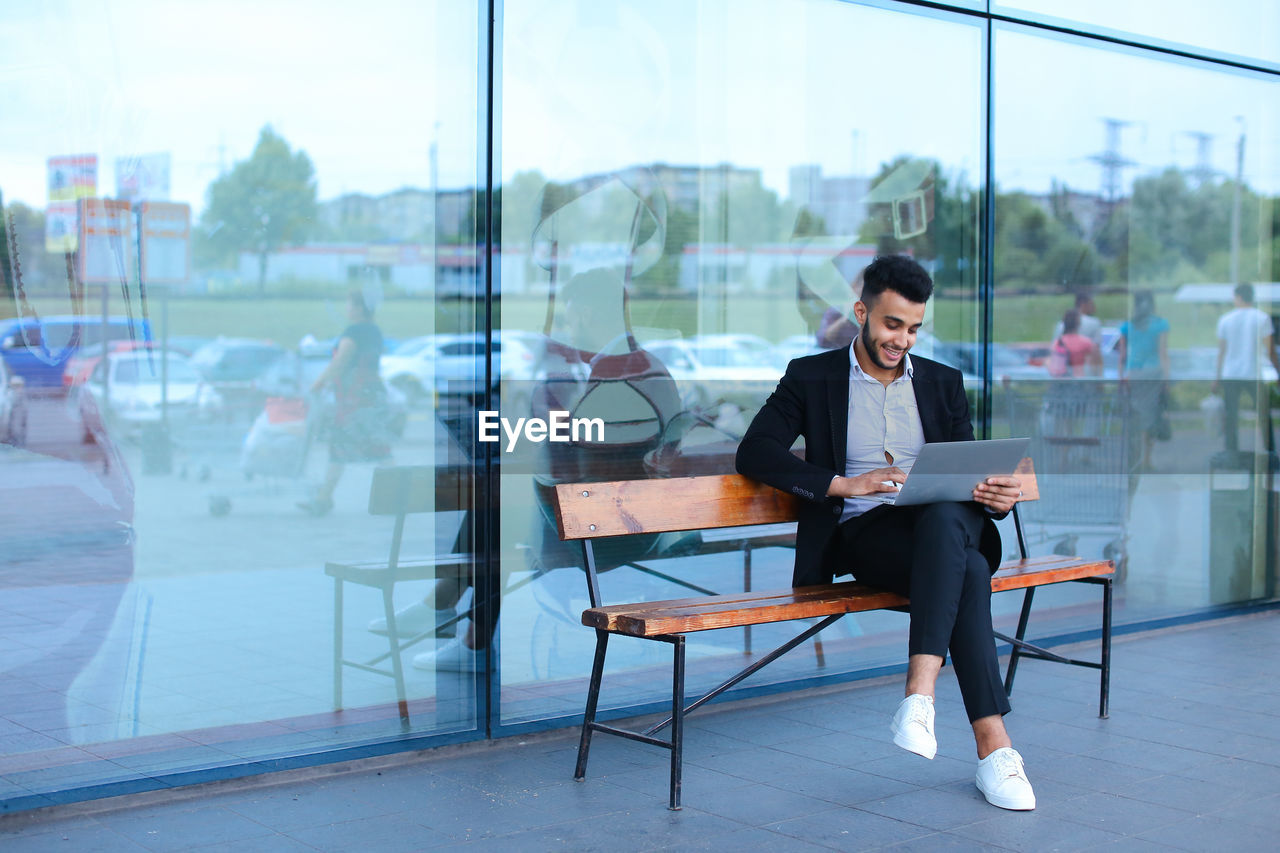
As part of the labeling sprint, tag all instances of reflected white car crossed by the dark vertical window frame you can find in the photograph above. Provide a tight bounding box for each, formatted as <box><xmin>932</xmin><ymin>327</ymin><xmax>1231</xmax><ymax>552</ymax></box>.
<box><xmin>380</xmin><ymin>330</ymin><xmax>541</xmax><ymax>403</ymax></box>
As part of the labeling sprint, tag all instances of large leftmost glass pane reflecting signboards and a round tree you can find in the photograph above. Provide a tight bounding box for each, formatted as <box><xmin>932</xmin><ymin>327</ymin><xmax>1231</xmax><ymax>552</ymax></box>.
<box><xmin>0</xmin><ymin>0</ymin><xmax>483</xmax><ymax>811</ymax></box>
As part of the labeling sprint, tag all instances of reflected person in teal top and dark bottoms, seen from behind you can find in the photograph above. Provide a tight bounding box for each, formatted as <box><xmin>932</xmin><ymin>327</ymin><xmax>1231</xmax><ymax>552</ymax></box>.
<box><xmin>1120</xmin><ymin>291</ymin><xmax>1169</xmax><ymax>470</ymax></box>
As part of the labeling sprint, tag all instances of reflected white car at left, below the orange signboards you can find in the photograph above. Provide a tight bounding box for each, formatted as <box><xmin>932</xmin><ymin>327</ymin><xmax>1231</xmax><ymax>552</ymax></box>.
<box><xmin>84</xmin><ymin>351</ymin><xmax>223</xmax><ymax>432</ymax></box>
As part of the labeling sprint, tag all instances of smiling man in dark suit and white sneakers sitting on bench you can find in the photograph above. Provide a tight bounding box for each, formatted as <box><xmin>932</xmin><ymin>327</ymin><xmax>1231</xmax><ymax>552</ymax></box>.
<box><xmin>737</xmin><ymin>256</ymin><xmax>1036</xmax><ymax>809</ymax></box>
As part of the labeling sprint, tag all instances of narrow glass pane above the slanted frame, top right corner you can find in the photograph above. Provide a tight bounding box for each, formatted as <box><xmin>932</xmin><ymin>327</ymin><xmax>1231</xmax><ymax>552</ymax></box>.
<box><xmin>992</xmin><ymin>0</ymin><xmax>1280</xmax><ymax>65</ymax></box>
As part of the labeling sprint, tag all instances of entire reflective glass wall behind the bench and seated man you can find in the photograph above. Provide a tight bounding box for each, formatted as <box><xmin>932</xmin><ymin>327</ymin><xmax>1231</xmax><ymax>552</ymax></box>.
<box><xmin>0</xmin><ymin>0</ymin><xmax>1280</xmax><ymax>811</ymax></box>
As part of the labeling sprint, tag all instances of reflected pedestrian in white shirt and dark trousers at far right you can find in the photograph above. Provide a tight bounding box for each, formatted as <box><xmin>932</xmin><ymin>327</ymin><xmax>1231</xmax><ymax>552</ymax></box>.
<box><xmin>1213</xmin><ymin>284</ymin><xmax>1280</xmax><ymax>451</ymax></box>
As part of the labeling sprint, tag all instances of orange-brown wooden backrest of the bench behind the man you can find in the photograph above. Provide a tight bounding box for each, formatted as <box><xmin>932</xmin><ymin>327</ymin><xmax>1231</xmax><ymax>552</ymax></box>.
<box><xmin>554</xmin><ymin>459</ymin><xmax>1039</xmax><ymax>540</ymax></box>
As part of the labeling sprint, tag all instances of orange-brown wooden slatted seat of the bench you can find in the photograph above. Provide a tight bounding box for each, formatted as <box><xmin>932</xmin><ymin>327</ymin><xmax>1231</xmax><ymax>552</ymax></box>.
<box><xmin>582</xmin><ymin>557</ymin><xmax>1115</xmax><ymax>637</ymax></box>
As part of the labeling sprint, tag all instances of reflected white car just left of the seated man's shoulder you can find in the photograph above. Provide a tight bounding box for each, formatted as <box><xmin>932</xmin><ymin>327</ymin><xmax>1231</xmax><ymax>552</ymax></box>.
<box><xmin>644</xmin><ymin>336</ymin><xmax>783</xmax><ymax>409</ymax></box>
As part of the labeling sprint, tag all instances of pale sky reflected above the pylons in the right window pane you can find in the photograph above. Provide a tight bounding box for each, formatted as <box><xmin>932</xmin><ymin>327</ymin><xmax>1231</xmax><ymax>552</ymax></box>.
<box><xmin>992</xmin><ymin>28</ymin><xmax>1280</xmax><ymax>192</ymax></box>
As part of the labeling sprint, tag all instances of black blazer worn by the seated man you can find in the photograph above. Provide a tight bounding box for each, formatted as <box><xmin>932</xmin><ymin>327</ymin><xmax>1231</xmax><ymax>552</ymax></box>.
<box><xmin>737</xmin><ymin>347</ymin><xmax>1001</xmax><ymax>587</ymax></box>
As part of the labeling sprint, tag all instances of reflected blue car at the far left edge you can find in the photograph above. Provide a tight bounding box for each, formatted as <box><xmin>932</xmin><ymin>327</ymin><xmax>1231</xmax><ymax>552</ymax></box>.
<box><xmin>0</xmin><ymin>315</ymin><xmax>151</xmax><ymax>391</ymax></box>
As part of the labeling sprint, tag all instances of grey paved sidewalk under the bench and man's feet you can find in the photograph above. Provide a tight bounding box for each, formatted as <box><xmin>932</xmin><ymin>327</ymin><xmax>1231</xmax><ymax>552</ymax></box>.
<box><xmin>0</xmin><ymin>611</ymin><xmax>1280</xmax><ymax>853</ymax></box>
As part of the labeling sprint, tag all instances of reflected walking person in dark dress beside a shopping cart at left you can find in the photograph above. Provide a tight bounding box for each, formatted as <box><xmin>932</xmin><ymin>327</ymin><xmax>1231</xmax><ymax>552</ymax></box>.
<box><xmin>298</xmin><ymin>291</ymin><xmax>390</xmax><ymax>515</ymax></box>
